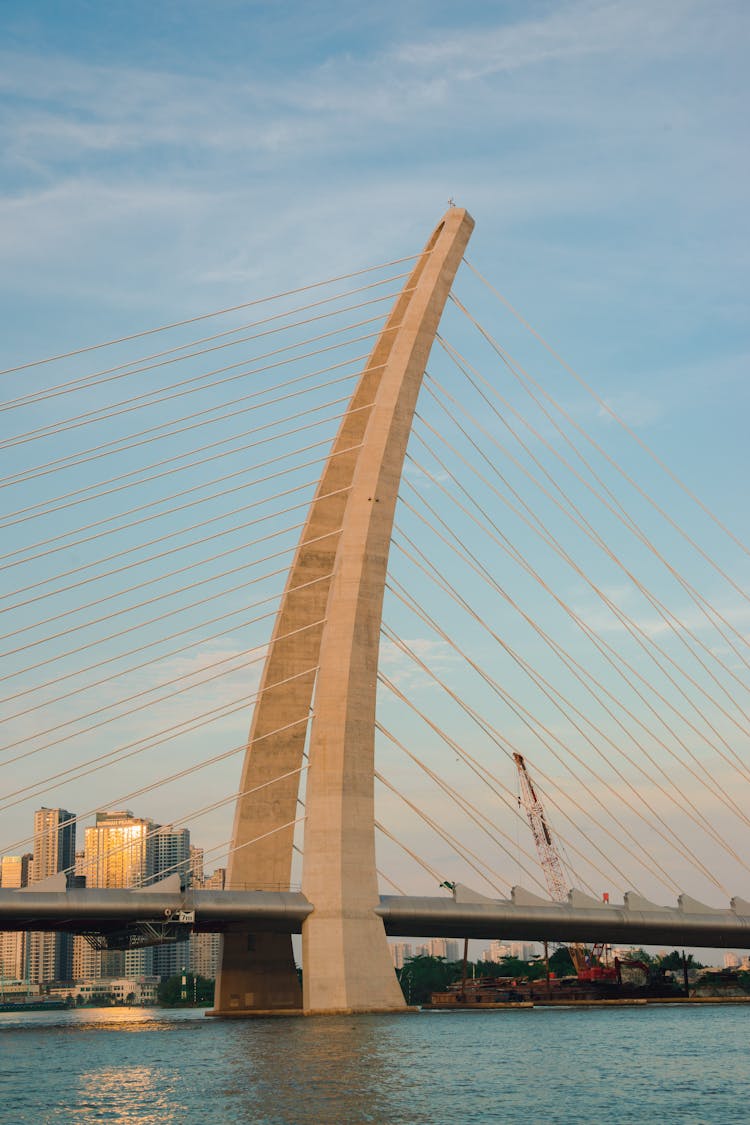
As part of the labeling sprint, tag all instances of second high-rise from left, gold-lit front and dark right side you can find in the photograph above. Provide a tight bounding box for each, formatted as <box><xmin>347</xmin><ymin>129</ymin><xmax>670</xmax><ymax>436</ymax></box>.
<box><xmin>26</xmin><ymin>809</ymin><xmax>75</xmax><ymax>984</ymax></box>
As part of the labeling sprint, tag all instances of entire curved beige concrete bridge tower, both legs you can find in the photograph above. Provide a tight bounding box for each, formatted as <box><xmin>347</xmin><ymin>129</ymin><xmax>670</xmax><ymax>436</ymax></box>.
<box><xmin>215</xmin><ymin>207</ymin><xmax>473</xmax><ymax>1016</ymax></box>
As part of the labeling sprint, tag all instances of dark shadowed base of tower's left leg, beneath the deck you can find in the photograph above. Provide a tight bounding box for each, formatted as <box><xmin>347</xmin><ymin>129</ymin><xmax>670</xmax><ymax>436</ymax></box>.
<box><xmin>208</xmin><ymin>929</ymin><xmax>302</xmax><ymax>1017</ymax></box>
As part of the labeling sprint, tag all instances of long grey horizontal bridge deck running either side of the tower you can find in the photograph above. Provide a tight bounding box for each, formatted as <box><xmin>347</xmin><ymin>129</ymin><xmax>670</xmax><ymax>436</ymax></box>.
<box><xmin>0</xmin><ymin>889</ymin><xmax>750</xmax><ymax>950</ymax></box>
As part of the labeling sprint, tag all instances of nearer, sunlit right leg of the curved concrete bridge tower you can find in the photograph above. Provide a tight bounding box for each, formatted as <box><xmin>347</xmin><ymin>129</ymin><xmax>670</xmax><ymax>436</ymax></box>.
<box><xmin>302</xmin><ymin>208</ymin><xmax>473</xmax><ymax>1011</ymax></box>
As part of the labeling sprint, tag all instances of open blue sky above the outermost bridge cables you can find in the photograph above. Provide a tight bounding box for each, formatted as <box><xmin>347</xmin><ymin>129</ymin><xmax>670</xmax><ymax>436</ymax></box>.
<box><xmin>0</xmin><ymin>0</ymin><xmax>750</xmax><ymax>931</ymax></box>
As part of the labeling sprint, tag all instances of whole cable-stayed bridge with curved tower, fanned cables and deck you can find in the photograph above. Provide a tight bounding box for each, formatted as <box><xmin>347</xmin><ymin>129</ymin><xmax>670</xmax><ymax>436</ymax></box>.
<box><xmin>0</xmin><ymin>208</ymin><xmax>750</xmax><ymax>1013</ymax></box>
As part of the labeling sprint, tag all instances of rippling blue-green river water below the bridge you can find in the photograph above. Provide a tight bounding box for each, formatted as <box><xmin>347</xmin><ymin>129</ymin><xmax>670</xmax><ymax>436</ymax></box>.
<box><xmin>0</xmin><ymin>1006</ymin><xmax>750</xmax><ymax>1125</ymax></box>
